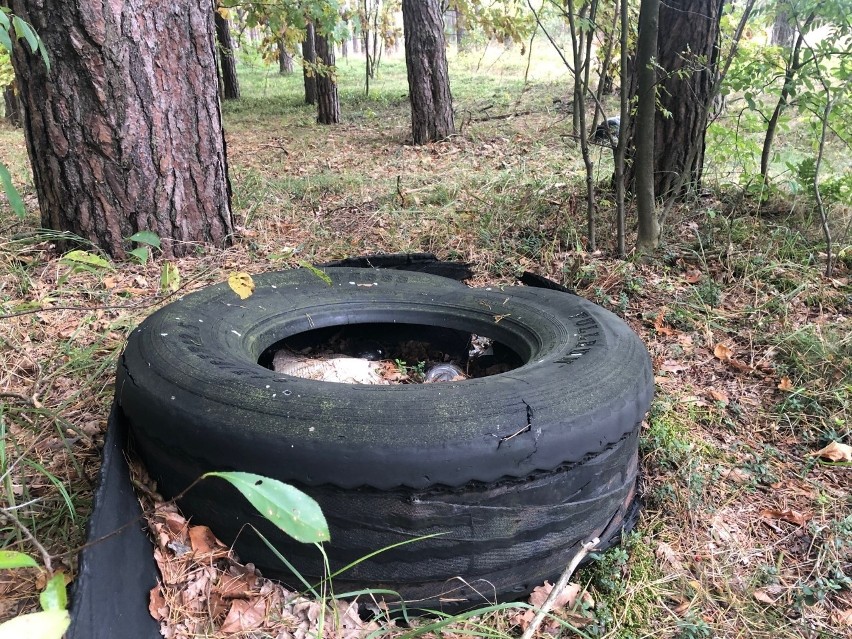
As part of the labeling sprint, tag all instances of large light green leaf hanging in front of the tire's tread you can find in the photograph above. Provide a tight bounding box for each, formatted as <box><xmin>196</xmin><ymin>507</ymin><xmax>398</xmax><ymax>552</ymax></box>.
<box><xmin>204</xmin><ymin>472</ymin><xmax>331</xmax><ymax>543</ymax></box>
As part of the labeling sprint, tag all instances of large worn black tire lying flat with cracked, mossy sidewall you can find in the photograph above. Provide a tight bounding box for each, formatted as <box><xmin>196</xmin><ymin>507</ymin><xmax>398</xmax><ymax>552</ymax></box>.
<box><xmin>116</xmin><ymin>268</ymin><xmax>653</xmax><ymax>608</ymax></box>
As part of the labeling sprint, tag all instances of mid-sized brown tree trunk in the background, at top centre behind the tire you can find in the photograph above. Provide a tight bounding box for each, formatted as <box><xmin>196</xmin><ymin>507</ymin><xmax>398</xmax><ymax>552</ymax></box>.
<box><xmin>402</xmin><ymin>0</ymin><xmax>455</xmax><ymax>144</ymax></box>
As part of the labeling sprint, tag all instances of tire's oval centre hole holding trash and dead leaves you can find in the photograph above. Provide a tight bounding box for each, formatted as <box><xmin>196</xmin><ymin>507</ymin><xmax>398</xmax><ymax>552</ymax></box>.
<box><xmin>258</xmin><ymin>323</ymin><xmax>524</xmax><ymax>384</ymax></box>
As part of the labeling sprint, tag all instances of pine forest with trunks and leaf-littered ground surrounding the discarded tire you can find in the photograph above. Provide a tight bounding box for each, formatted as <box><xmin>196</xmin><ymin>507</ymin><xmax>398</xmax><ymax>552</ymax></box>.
<box><xmin>0</xmin><ymin>0</ymin><xmax>852</xmax><ymax>638</ymax></box>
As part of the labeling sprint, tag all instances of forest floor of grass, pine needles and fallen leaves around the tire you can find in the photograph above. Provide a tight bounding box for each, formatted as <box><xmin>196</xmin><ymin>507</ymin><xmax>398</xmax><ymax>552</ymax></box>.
<box><xmin>0</xmin><ymin>46</ymin><xmax>852</xmax><ymax>639</ymax></box>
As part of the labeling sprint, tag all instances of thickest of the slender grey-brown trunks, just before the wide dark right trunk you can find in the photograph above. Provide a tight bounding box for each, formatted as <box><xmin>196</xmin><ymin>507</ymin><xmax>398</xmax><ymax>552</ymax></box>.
<box><xmin>635</xmin><ymin>0</ymin><xmax>660</xmax><ymax>252</ymax></box>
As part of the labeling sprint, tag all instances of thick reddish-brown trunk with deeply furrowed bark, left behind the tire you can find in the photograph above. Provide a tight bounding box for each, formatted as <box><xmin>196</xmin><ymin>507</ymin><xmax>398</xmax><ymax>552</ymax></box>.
<box><xmin>10</xmin><ymin>0</ymin><xmax>233</xmax><ymax>258</ymax></box>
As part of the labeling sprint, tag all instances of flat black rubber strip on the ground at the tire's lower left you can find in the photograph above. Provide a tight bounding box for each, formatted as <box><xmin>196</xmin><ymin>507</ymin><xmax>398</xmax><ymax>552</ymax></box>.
<box><xmin>68</xmin><ymin>410</ymin><xmax>161</xmax><ymax>639</ymax></box>
